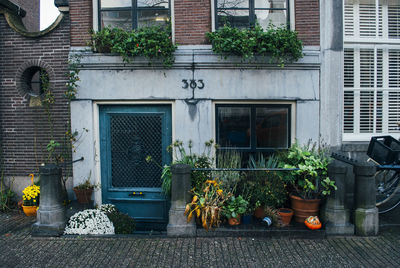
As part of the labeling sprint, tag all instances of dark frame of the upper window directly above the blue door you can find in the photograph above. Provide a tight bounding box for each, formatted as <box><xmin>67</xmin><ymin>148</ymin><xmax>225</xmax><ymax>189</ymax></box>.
<box><xmin>97</xmin><ymin>0</ymin><xmax>171</xmax><ymax>30</ymax></box>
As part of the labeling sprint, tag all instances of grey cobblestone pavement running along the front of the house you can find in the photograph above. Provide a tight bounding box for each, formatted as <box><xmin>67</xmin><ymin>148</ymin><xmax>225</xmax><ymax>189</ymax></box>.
<box><xmin>0</xmin><ymin>214</ymin><xmax>400</xmax><ymax>267</ymax></box>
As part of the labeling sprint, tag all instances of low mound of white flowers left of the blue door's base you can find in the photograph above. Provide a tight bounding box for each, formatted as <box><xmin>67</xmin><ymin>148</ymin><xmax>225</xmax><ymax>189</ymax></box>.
<box><xmin>64</xmin><ymin>209</ymin><xmax>115</xmax><ymax>235</ymax></box>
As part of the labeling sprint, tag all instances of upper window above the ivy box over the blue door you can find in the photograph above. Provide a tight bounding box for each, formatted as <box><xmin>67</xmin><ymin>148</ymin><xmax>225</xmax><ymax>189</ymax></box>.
<box><xmin>99</xmin><ymin>0</ymin><xmax>170</xmax><ymax>30</ymax></box>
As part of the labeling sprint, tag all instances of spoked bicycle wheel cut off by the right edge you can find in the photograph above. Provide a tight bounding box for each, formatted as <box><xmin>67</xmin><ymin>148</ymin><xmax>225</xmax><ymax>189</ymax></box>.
<box><xmin>375</xmin><ymin>171</ymin><xmax>400</xmax><ymax>207</ymax></box>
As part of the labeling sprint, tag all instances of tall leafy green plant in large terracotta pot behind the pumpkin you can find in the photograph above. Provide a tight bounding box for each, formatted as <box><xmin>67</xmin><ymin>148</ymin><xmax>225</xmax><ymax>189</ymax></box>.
<box><xmin>281</xmin><ymin>143</ymin><xmax>336</xmax><ymax>223</ymax></box>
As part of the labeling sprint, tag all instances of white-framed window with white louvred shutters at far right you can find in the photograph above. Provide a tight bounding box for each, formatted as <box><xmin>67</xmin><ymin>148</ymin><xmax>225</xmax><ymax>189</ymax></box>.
<box><xmin>342</xmin><ymin>0</ymin><xmax>400</xmax><ymax>141</ymax></box>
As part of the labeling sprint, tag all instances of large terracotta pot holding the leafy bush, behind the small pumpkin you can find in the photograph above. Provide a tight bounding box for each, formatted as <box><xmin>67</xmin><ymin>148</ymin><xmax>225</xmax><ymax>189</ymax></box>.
<box><xmin>290</xmin><ymin>195</ymin><xmax>321</xmax><ymax>223</ymax></box>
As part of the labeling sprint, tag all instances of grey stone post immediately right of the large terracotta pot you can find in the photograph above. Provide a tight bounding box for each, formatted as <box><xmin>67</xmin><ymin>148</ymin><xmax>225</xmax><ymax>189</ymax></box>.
<box><xmin>324</xmin><ymin>161</ymin><xmax>354</xmax><ymax>235</ymax></box>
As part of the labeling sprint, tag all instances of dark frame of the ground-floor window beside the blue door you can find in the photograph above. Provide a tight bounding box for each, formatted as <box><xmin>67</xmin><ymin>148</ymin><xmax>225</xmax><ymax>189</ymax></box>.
<box><xmin>214</xmin><ymin>102</ymin><xmax>294</xmax><ymax>154</ymax></box>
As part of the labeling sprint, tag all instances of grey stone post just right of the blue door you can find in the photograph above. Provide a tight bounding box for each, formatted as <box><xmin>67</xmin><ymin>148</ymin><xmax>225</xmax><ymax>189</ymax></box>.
<box><xmin>167</xmin><ymin>164</ymin><xmax>196</xmax><ymax>236</ymax></box>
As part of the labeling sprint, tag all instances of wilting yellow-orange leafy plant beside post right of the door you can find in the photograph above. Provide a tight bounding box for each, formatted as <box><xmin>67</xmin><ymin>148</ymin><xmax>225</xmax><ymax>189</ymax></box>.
<box><xmin>184</xmin><ymin>179</ymin><xmax>232</xmax><ymax>230</ymax></box>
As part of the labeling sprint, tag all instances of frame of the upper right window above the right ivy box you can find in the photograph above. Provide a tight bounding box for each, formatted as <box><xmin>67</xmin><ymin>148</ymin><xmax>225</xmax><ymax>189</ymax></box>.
<box><xmin>211</xmin><ymin>0</ymin><xmax>294</xmax><ymax>31</ymax></box>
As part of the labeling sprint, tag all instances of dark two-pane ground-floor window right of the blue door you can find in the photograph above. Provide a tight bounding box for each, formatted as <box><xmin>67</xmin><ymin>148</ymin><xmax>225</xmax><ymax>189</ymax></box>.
<box><xmin>216</xmin><ymin>104</ymin><xmax>291</xmax><ymax>158</ymax></box>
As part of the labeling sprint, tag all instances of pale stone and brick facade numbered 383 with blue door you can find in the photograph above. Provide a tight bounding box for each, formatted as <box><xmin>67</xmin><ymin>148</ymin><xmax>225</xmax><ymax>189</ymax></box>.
<box><xmin>70</xmin><ymin>0</ymin><xmax>343</xmax><ymax>230</ymax></box>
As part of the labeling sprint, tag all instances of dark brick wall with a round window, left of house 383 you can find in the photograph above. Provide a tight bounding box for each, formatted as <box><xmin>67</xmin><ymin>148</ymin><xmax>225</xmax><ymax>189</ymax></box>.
<box><xmin>0</xmin><ymin>14</ymin><xmax>70</xmax><ymax>176</ymax></box>
